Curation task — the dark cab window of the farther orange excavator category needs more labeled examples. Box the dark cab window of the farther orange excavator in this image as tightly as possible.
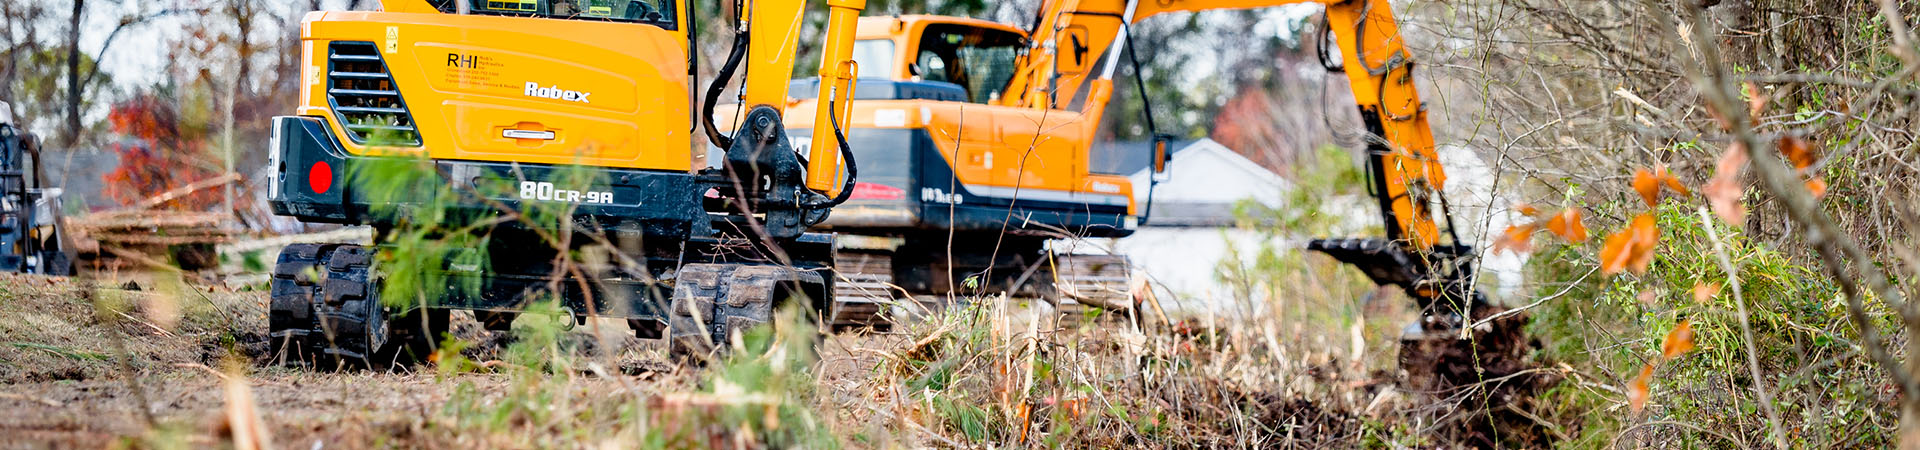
[910,25,1025,104]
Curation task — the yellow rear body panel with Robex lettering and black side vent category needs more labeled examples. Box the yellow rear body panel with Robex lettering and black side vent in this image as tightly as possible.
[298,0,693,171]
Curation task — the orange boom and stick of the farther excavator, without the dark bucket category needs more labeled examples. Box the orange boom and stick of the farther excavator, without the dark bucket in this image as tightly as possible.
[1002,0,1446,252]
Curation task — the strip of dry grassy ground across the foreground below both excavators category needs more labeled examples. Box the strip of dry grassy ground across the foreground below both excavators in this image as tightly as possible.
[0,255,1559,448]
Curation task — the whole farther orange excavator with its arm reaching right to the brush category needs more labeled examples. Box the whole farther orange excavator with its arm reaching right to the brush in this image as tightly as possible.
[787,0,1484,327]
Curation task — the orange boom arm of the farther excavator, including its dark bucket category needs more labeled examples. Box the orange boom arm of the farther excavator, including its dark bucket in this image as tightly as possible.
[1000,0,1480,315]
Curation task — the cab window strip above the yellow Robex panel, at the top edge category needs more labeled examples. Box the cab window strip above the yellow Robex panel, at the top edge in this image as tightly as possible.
[430,0,680,29]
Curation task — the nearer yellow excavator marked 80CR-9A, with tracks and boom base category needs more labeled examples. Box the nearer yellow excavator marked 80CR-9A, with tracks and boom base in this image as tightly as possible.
[267,0,866,362]
